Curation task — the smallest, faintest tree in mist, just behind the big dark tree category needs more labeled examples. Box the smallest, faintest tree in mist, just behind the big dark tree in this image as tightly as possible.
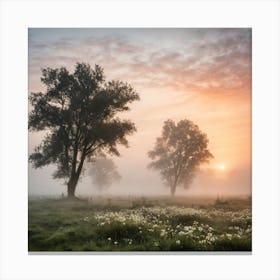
[88,157,121,191]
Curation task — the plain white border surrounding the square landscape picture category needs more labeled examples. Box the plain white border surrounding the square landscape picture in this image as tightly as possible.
[0,0,280,280]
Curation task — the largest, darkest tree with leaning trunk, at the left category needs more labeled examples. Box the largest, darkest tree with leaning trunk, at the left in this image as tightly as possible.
[29,63,139,198]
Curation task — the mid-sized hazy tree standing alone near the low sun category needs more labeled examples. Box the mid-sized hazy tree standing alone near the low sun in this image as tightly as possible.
[148,119,213,195]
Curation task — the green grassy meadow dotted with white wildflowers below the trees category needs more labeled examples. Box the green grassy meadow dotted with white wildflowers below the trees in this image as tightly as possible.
[28,197,252,251]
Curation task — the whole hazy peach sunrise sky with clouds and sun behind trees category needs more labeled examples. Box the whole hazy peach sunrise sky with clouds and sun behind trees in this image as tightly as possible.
[28,28,252,195]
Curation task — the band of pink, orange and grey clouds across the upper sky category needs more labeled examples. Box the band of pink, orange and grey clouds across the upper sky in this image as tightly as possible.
[30,29,251,99]
